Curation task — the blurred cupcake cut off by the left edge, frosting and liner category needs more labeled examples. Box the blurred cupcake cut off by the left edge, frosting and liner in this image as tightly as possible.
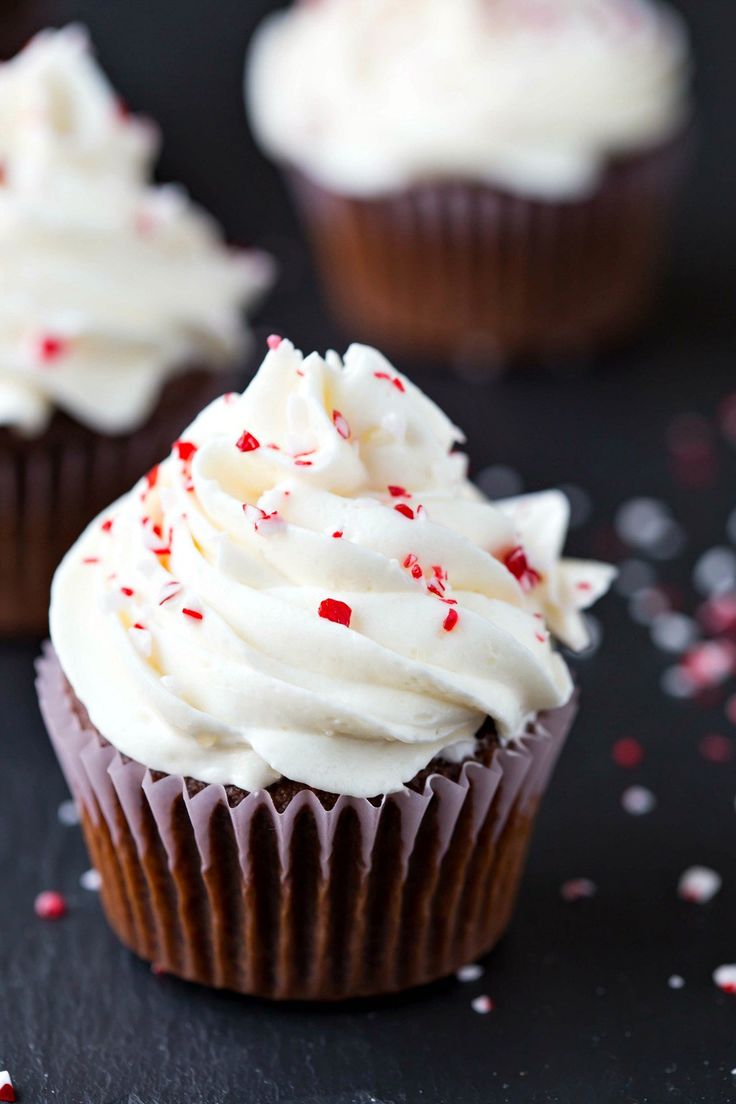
[0,28,269,635]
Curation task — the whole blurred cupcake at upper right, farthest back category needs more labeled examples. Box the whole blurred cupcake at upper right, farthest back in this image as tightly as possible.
[247,0,690,365]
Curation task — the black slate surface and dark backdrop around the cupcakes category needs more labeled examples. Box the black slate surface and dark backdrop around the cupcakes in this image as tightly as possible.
[0,0,736,1104]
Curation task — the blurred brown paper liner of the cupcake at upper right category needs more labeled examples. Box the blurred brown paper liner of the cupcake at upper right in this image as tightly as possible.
[292,138,689,362]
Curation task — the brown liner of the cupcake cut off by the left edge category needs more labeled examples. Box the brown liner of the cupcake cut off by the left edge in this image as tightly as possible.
[0,369,233,636]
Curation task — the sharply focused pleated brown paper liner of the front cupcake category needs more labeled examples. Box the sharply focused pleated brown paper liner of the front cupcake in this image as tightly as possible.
[38,646,576,1000]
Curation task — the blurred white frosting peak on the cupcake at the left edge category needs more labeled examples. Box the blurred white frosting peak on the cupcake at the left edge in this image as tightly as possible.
[0,28,269,434]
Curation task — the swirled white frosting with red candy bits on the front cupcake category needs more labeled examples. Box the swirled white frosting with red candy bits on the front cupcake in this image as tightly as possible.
[51,341,612,797]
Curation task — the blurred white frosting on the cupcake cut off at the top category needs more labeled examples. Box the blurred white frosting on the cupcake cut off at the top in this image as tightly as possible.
[247,0,690,200]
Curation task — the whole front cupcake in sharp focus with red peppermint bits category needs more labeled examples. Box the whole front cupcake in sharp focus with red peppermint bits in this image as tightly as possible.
[39,339,611,999]
